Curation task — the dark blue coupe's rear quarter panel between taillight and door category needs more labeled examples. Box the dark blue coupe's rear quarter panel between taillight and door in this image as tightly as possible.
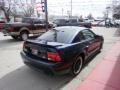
[58,43,85,64]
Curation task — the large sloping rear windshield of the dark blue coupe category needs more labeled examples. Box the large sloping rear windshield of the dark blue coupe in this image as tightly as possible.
[38,30,74,43]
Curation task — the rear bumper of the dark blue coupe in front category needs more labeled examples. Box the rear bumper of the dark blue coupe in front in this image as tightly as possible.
[20,51,70,74]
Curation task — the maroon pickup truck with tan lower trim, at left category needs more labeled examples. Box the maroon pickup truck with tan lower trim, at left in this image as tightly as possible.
[2,17,52,40]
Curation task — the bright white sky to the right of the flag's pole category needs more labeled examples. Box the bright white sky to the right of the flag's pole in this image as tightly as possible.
[47,0,112,17]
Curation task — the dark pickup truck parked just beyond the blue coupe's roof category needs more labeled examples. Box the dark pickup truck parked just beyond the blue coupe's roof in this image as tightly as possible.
[53,19,91,28]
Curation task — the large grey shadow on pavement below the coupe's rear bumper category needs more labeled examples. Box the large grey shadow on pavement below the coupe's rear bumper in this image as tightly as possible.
[0,66,73,90]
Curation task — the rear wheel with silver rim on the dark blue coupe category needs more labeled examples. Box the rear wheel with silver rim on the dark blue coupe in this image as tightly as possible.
[71,56,83,76]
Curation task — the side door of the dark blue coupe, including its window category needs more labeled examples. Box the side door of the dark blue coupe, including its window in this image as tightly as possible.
[81,29,97,55]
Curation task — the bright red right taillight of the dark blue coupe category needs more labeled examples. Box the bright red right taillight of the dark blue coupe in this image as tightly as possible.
[47,52,61,62]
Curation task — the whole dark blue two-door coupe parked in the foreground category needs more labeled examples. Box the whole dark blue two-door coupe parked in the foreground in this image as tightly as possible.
[21,26,104,75]
